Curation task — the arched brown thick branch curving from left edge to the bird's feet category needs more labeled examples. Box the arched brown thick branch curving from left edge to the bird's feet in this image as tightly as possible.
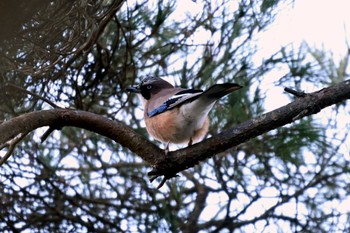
[0,109,163,164]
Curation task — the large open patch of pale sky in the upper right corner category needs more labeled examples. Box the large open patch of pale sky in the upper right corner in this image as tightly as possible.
[261,0,350,58]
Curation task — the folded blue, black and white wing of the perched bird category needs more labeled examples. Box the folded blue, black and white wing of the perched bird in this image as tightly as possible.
[148,89,203,117]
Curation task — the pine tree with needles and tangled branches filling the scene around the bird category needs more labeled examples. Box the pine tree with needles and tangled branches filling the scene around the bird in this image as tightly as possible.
[0,0,350,232]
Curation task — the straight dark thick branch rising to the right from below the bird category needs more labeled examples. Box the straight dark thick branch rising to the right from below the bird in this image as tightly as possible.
[149,80,350,177]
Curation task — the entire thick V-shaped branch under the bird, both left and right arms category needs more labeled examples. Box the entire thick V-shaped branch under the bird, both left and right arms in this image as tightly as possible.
[0,80,350,184]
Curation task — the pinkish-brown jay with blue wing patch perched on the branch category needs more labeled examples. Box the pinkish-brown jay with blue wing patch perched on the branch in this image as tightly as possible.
[127,76,242,153]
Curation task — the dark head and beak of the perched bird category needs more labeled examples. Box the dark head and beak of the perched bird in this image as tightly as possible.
[126,76,174,100]
